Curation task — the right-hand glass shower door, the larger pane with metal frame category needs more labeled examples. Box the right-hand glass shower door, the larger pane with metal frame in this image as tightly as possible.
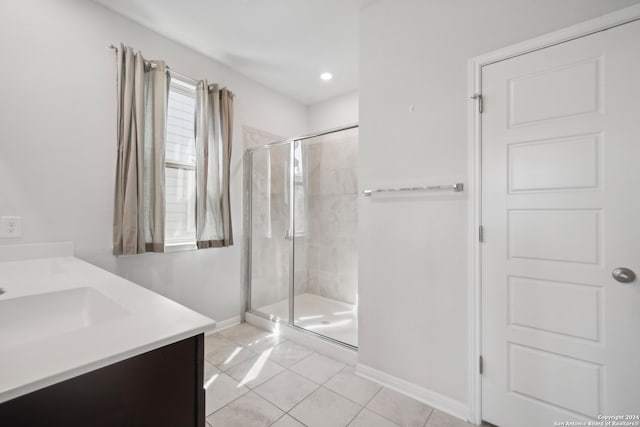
[290,129,358,347]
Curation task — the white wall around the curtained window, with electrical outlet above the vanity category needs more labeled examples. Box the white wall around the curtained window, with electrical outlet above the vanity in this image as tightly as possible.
[0,0,307,320]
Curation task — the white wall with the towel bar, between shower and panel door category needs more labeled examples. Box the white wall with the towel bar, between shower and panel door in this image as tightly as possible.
[358,0,637,414]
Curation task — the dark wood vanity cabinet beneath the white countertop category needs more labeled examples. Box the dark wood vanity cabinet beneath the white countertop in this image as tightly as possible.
[0,334,205,427]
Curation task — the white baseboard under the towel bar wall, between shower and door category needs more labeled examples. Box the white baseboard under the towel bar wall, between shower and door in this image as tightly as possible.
[356,363,469,421]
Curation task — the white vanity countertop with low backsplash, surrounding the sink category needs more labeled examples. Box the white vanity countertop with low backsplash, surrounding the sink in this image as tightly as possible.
[0,244,215,402]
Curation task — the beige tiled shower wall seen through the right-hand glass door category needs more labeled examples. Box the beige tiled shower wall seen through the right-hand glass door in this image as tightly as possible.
[299,130,358,304]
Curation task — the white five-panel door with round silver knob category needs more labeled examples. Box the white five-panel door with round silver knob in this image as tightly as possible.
[482,18,640,427]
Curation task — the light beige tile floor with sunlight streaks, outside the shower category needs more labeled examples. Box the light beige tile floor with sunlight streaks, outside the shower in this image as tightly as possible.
[204,323,478,427]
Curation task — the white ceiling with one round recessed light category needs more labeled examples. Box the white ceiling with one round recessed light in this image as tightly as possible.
[94,0,373,105]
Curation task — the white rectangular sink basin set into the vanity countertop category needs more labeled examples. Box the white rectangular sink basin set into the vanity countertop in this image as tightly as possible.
[0,287,129,348]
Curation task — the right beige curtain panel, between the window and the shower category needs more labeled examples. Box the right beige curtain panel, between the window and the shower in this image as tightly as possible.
[195,80,233,249]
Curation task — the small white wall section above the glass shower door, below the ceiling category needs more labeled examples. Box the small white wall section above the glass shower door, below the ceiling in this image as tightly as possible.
[307,92,359,133]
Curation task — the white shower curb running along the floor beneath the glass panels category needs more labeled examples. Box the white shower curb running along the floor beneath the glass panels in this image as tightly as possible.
[245,313,358,365]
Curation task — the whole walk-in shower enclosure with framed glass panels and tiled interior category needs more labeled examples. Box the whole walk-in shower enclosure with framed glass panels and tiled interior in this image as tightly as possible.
[244,125,358,347]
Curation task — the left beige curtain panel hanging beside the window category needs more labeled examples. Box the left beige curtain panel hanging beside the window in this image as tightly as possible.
[113,44,169,255]
